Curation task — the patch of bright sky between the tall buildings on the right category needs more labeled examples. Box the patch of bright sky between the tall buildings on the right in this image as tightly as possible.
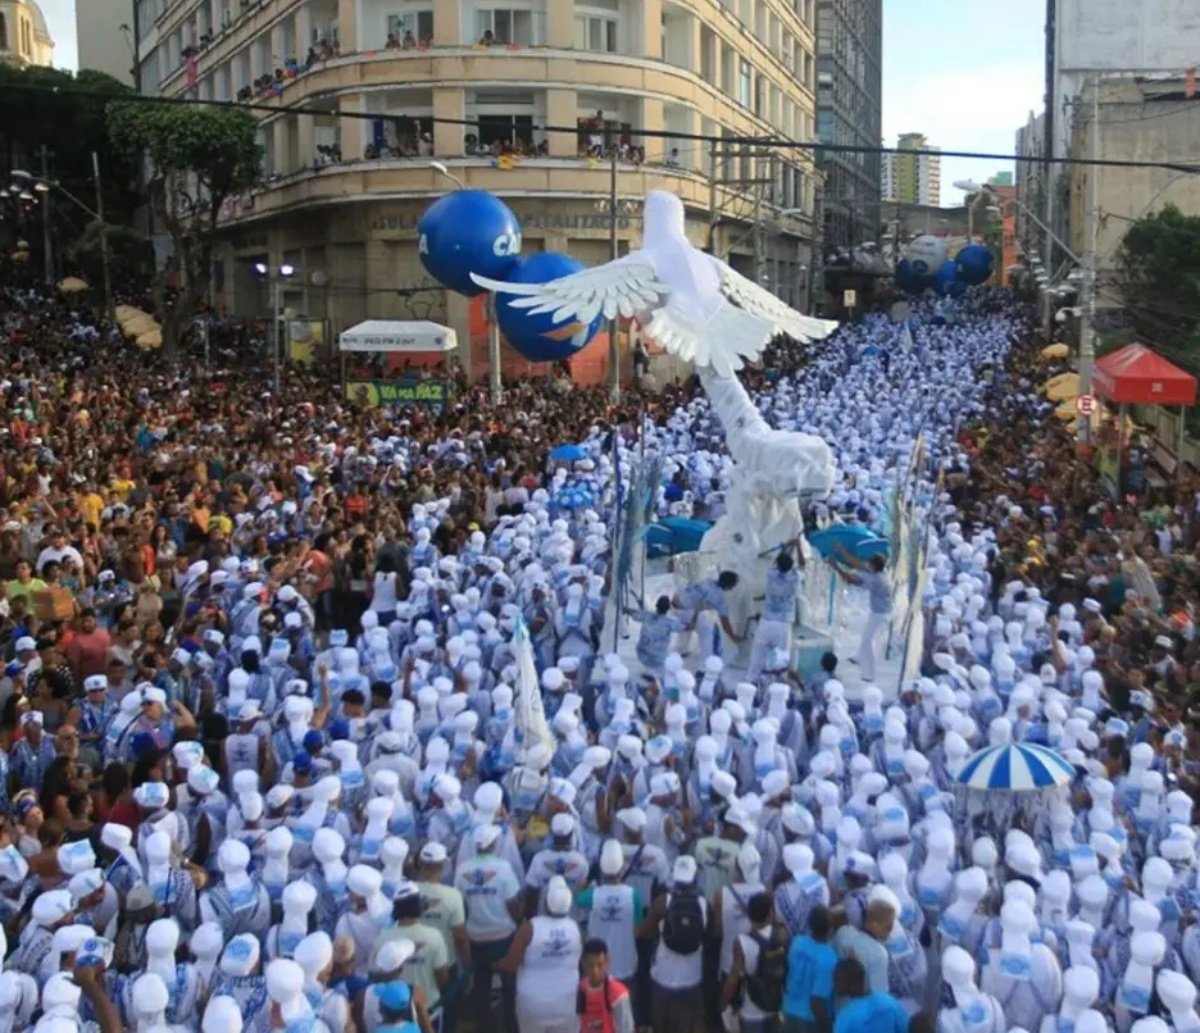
[883,0,1045,206]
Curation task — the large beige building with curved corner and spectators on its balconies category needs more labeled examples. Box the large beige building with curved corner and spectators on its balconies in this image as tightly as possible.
[137,0,817,369]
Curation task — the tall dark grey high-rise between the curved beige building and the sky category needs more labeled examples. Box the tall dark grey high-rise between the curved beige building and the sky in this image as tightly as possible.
[816,0,883,250]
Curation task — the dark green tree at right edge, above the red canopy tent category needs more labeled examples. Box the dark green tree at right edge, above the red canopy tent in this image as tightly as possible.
[1117,204,1200,348]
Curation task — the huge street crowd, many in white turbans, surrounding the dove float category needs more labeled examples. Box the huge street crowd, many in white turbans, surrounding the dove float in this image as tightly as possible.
[0,269,1200,1033]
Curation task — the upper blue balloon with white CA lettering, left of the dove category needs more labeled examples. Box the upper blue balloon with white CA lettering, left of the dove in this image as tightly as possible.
[416,190,521,298]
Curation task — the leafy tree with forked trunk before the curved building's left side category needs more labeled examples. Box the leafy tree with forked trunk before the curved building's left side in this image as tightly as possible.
[108,103,263,356]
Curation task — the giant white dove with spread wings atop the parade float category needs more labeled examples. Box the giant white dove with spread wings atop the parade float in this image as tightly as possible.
[470,191,838,377]
